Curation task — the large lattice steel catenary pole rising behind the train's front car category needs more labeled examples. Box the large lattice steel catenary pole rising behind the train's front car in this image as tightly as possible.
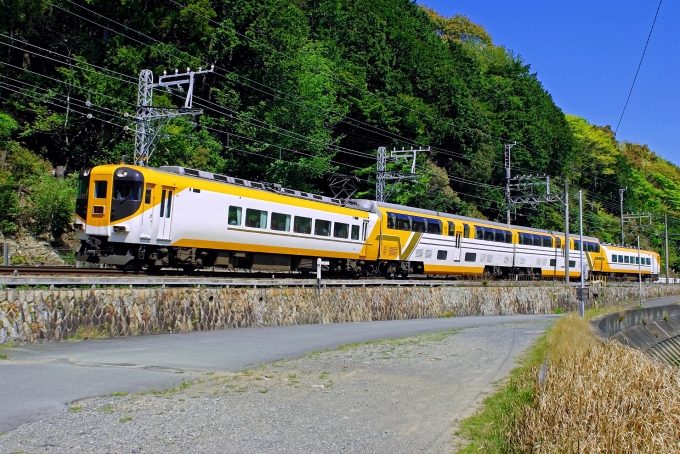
[134,67,213,166]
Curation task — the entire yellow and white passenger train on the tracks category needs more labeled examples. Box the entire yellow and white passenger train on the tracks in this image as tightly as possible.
[74,164,659,279]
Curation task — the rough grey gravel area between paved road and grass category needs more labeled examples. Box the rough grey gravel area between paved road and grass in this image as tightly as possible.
[0,322,548,453]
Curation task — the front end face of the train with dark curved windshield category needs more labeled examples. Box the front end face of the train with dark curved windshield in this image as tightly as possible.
[74,165,150,269]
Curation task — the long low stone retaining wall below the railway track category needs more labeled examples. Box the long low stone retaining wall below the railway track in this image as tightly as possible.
[0,285,680,344]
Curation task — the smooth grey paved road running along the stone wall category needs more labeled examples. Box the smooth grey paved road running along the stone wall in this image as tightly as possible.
[0,315,557,431]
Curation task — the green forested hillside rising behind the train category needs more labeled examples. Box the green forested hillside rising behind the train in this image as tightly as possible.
[0,0,680,267]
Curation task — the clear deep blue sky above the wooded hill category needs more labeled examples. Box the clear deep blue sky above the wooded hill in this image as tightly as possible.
[417,0,680,165]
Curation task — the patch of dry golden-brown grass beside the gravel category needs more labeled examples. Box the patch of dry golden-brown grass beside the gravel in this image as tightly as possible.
[508,317,680,453]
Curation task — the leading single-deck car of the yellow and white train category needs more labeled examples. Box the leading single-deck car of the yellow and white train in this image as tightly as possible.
[77,165,386,274]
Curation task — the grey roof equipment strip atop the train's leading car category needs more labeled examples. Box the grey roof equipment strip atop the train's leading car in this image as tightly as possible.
[155,166,369,211]
